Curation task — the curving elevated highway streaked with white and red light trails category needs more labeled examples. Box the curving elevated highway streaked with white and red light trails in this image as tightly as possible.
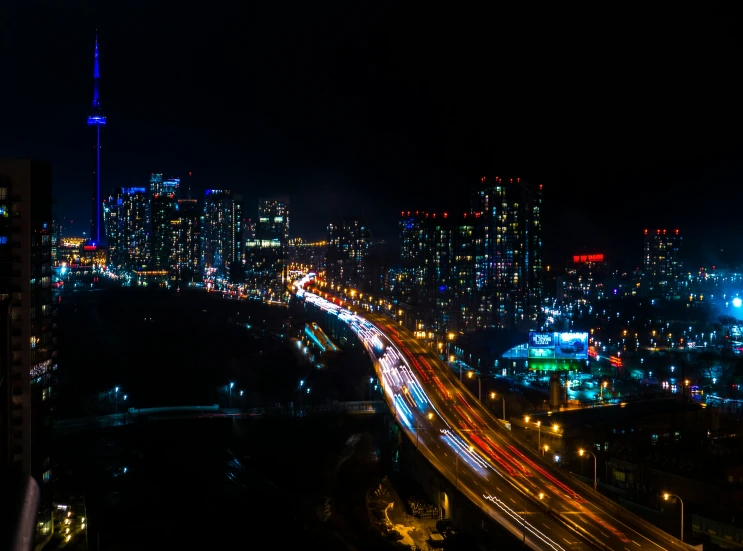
[295,278,692,551]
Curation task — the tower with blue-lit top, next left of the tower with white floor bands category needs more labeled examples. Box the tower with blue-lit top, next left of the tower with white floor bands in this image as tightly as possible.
[201,189,242,280]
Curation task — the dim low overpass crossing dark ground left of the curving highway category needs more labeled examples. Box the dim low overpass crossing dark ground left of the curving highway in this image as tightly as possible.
[53,401,389,437]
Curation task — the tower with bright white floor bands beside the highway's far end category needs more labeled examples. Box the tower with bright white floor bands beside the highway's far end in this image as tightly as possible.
[245,197,289,294]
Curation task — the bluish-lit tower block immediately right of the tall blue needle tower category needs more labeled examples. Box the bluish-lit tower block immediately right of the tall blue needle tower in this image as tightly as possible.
[104,187,149,270]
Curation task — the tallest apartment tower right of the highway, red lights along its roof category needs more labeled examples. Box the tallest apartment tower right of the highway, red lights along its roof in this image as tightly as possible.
[471,176,542,329]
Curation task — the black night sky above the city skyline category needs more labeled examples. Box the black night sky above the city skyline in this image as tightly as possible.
[0,0,743,268]
